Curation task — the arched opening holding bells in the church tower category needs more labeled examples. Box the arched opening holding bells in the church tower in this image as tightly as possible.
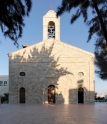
[48,21,55,39]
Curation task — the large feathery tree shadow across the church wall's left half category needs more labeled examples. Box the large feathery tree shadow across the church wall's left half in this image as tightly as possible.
[14,43,72,103]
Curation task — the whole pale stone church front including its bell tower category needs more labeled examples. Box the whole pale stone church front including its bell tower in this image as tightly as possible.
[8,10,94,104]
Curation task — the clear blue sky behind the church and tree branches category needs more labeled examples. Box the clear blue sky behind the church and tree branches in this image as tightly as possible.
[0,0,107,94]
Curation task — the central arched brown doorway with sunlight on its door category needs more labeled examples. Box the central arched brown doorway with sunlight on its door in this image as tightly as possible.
[48,85,55,104]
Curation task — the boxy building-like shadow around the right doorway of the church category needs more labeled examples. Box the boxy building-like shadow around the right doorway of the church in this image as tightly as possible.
[69,79,95,104]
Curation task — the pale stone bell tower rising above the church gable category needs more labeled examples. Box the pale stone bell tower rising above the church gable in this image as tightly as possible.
[43,10,60,40]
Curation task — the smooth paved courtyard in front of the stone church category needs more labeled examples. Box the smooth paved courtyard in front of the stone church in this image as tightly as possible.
[0,102,107,124]
